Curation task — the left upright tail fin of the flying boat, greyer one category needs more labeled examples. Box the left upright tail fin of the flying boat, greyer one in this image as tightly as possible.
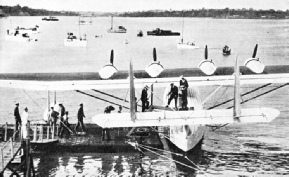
[129,61,136,121]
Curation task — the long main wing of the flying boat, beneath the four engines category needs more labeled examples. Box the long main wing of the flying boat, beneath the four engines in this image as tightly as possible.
[0,65,289,90]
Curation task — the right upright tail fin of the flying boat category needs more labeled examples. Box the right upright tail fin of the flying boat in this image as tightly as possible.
[234,55,241,118]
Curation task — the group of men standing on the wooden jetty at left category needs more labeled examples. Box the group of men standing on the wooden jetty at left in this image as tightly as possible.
[14,103,85,138]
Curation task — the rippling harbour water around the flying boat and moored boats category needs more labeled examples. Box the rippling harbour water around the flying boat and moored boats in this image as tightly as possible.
[0,17,289,176]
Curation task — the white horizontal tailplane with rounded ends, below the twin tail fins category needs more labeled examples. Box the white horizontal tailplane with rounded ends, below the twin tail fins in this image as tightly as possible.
[92,108,280,128]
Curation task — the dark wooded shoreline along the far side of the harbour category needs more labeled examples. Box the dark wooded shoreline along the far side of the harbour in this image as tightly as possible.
[0,5,289,19]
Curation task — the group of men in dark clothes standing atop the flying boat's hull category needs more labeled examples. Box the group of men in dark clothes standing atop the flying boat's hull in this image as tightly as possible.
[141,76,189,112]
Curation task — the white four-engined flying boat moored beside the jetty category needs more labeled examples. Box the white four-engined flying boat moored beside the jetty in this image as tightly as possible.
[0,46,289,152]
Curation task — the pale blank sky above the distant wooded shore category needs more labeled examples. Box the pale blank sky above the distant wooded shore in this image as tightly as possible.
[0,0,289,12]
